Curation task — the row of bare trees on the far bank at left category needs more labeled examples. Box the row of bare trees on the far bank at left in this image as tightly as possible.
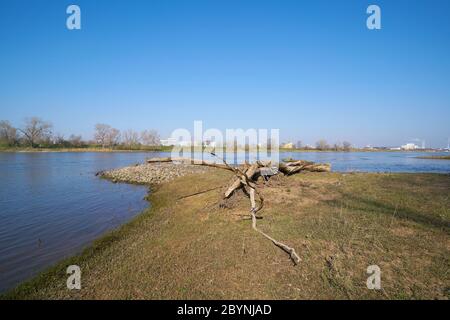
[0,117,160,150]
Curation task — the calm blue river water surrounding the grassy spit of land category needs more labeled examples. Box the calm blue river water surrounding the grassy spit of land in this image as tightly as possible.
[0,152,450,292]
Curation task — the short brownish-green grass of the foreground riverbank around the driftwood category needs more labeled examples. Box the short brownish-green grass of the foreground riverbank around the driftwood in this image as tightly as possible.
[3,170,450,299]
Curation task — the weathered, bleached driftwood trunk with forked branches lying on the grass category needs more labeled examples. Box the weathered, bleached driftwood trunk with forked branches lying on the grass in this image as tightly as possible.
[147,153,331,265]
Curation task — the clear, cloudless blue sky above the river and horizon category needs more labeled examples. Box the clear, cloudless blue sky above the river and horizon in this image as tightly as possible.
[0,0,450,147]
